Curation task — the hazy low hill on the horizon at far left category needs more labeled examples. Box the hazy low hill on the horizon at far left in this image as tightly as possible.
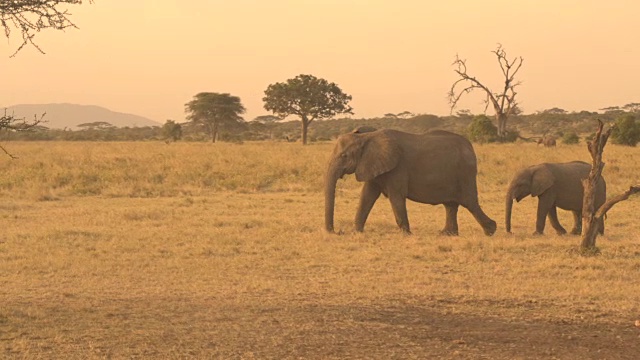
[7,104,162,130]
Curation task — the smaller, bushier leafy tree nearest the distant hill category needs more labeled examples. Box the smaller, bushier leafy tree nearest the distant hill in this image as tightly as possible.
[184,92,246,142]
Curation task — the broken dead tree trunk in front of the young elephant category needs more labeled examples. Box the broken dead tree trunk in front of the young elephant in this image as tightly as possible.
[580,120,640,253]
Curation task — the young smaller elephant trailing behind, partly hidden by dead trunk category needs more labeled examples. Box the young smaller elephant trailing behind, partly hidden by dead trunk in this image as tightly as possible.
[505,161,607,235]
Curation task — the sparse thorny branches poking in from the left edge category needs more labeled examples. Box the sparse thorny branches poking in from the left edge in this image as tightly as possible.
[0,0,93,158]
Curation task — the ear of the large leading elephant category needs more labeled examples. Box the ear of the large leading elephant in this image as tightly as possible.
[356,132,401,181]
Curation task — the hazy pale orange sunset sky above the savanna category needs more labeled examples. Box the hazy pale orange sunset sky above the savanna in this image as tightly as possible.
[0,0,640,123]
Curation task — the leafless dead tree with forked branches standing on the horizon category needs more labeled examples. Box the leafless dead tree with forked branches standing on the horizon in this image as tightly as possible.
[448,44,524,139]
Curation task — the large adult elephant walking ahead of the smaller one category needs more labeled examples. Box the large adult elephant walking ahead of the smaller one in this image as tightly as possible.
[325,129,496,235]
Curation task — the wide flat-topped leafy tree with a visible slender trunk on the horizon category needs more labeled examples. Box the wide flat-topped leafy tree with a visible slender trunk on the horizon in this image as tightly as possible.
[262,75,353,145]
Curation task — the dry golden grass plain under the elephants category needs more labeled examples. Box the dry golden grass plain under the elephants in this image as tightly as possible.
[0,142,640,359]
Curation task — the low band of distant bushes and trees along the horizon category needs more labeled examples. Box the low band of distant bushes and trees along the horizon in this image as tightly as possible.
[0,108,640,146]
